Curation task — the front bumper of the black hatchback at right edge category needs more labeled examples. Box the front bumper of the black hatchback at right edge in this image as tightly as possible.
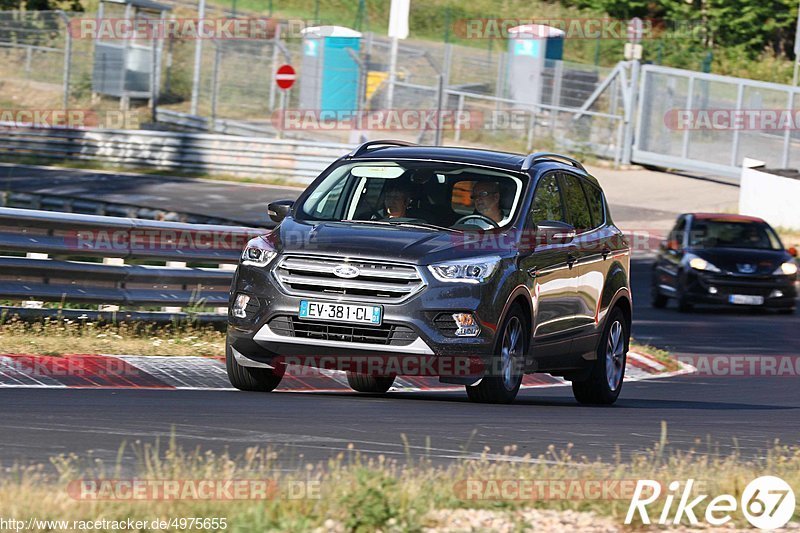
[684,270,798,309]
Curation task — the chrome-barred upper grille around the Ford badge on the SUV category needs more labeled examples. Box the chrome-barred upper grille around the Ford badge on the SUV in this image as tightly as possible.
[274,255,425,302]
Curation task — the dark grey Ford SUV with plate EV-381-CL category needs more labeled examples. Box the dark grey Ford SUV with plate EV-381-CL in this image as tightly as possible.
[226,141,631,404]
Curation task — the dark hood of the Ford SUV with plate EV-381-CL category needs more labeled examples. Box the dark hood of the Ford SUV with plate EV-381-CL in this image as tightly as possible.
[273,218,512,264]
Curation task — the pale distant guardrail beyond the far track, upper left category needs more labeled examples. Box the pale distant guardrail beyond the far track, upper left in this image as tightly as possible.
[0,123,352,183]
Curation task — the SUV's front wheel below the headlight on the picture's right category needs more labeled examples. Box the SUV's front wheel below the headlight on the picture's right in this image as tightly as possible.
[467,306,529,403]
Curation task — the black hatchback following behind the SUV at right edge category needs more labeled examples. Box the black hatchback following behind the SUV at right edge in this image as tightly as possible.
[651,213,797,313]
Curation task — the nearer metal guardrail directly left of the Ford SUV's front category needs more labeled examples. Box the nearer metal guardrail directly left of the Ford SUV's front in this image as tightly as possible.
[0,208,265,322]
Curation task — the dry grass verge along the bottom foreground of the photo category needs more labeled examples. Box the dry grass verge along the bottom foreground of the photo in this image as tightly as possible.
[0,425,800,531]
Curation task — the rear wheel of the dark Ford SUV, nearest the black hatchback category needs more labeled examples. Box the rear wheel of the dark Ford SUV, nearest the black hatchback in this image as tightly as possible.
[572,307,630,405]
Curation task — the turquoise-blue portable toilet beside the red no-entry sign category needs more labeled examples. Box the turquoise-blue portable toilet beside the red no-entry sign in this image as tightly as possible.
[299,26,361,117]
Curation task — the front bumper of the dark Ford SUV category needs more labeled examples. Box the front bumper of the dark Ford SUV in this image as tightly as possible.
[228,258,505,374]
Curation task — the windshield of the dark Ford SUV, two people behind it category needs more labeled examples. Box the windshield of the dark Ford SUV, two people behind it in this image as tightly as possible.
[296,161,526,230]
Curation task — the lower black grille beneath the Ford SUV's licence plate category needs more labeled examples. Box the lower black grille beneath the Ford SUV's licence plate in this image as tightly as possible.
[269,316,417,346]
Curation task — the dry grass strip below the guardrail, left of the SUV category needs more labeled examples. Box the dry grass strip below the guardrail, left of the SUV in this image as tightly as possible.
[0,318,225,356]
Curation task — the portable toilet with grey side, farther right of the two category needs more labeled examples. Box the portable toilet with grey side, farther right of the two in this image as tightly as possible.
[507,24,565,109]
